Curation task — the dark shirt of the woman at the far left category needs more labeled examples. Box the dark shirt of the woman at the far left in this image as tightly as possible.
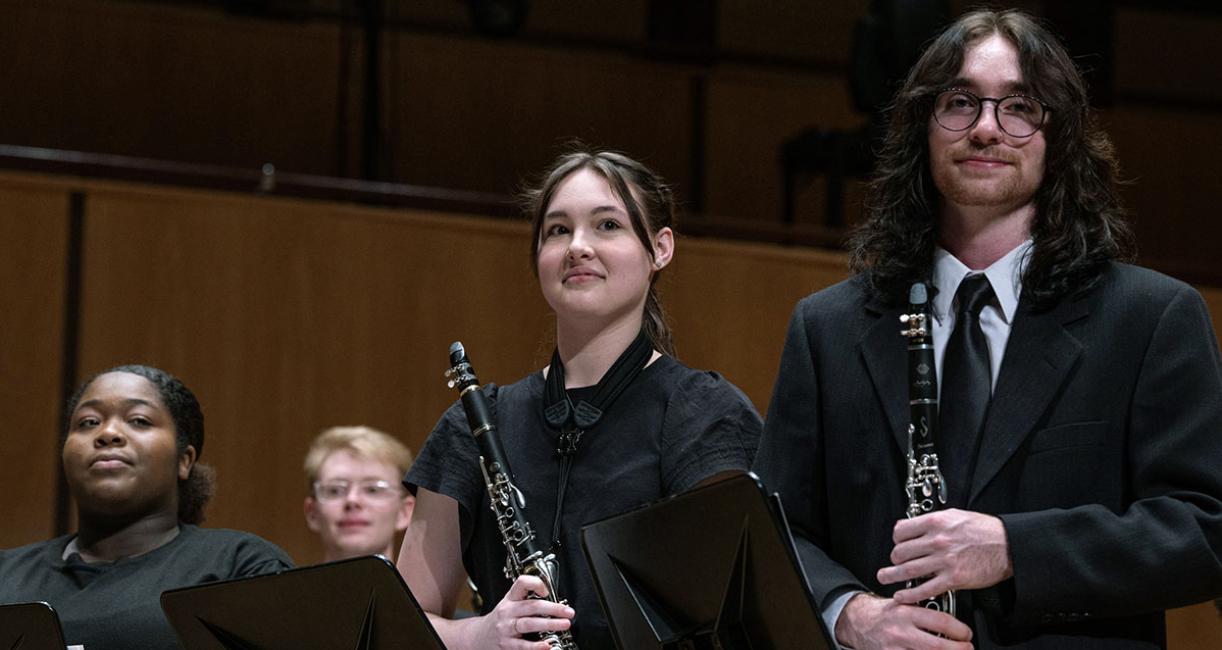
[0,524,292,650]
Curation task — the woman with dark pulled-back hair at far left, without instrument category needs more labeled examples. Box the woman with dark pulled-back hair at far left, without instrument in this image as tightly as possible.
[0,365,292,650]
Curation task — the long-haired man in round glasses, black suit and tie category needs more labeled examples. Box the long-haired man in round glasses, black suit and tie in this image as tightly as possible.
[755,10,1222,650]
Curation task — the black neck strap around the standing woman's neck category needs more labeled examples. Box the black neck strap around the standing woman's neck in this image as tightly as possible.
[543,329,654,444]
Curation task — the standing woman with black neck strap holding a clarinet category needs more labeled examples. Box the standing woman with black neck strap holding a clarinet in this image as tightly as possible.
[400,152,761,650]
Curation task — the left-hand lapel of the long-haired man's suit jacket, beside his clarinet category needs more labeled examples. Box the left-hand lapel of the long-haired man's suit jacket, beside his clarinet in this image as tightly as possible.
[858,301,910,453]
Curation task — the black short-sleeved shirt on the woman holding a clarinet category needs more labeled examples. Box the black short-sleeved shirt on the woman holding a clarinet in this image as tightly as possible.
[403,356,763,650]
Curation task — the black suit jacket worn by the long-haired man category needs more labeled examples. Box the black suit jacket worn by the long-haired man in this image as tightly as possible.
[755,264,1222,649]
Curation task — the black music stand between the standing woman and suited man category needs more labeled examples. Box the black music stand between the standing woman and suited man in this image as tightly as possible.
[582,473,836,650]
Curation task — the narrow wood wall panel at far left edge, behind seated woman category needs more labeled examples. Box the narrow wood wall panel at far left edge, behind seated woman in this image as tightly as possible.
[0,176,68,549]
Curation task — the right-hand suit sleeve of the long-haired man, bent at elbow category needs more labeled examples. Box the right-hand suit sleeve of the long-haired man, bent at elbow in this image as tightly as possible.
[1002,285,1222,624]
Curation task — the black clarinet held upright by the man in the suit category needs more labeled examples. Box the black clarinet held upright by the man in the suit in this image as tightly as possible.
[899,282,954,616]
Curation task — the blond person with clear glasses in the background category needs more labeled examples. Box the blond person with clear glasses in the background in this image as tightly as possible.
[306,426,415,562]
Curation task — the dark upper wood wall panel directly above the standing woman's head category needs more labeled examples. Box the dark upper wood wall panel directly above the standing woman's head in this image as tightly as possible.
[387,34,692,195]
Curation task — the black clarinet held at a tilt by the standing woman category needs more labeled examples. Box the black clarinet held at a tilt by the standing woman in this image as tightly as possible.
[446,341,578,650]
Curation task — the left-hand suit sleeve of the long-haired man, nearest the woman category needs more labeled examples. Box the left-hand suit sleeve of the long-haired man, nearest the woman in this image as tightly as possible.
[754,298,868,608]
